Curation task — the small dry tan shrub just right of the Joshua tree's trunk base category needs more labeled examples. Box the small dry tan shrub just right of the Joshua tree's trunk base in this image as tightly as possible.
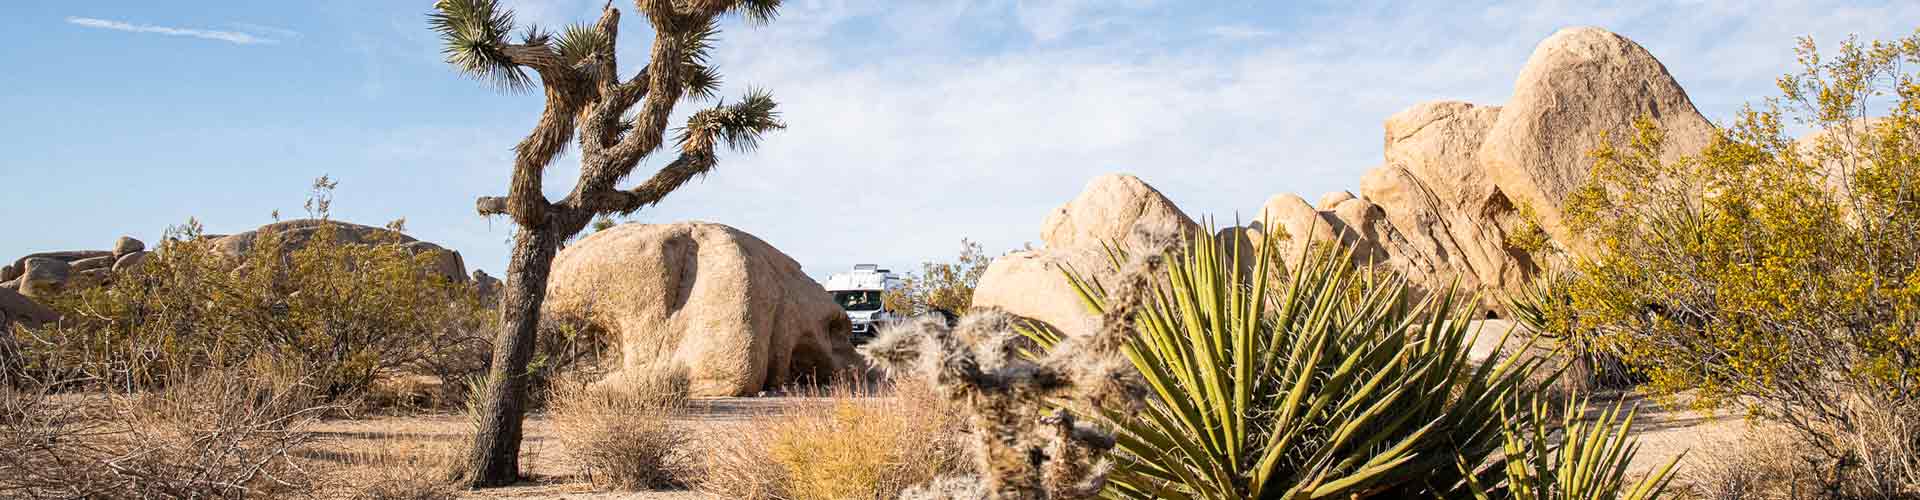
[547,369,697,490]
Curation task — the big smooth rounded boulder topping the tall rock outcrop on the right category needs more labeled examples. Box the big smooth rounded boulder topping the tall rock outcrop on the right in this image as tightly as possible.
[1478,27,1715,252]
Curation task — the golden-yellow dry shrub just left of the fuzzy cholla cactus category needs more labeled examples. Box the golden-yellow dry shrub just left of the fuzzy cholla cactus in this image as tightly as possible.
[699,381,966,500]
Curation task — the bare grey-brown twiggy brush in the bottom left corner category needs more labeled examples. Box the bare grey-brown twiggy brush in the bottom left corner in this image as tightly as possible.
[0,369,330,498]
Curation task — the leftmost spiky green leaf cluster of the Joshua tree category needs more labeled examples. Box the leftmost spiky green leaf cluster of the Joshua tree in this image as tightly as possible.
[426,0,534,90]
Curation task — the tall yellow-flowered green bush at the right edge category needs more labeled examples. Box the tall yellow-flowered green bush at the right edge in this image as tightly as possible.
[1569,35,1920,496]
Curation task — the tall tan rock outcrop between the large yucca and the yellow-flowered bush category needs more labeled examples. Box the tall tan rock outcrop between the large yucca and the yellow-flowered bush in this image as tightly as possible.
[1267,27,1715,310]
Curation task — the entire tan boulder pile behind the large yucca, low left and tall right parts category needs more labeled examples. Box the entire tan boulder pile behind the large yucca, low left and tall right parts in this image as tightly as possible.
[973,27,1716,329]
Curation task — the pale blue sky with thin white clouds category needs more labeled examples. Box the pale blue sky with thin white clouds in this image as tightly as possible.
[0,0,1920,277]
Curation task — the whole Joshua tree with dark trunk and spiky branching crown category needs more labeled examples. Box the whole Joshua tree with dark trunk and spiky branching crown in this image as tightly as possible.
[428,0,783,487]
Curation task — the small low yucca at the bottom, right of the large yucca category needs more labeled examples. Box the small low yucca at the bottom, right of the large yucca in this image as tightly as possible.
[1459,396,1686,500]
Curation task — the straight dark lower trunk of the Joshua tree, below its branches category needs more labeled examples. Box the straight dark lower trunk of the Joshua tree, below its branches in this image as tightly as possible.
[467,229,561,487]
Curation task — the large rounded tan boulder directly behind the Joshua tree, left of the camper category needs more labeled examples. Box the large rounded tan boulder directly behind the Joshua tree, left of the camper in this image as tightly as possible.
[545,223,858,396]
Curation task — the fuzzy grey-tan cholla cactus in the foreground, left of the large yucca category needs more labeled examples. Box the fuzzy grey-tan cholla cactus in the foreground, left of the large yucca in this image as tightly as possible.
[862,252,1160,498]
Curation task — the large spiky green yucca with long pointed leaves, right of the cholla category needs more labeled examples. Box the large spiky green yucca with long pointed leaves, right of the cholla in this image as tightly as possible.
[1029,228,1540,498]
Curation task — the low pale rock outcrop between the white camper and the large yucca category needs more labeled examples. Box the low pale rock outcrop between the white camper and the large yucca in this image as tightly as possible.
[973,175,1200,333]
